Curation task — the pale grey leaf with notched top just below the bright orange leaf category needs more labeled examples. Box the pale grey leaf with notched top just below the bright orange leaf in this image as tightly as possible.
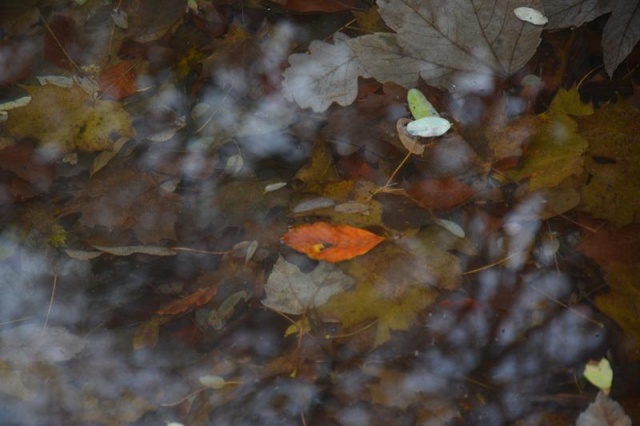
[262,257,355,315]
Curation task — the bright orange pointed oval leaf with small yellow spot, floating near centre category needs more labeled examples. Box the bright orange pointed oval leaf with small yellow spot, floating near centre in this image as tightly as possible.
[282,222,384,263]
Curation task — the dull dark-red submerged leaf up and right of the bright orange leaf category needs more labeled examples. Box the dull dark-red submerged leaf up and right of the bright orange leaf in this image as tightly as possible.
[407,179,473,210]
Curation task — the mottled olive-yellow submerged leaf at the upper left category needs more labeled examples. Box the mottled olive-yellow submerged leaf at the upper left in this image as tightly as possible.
[6,85,133,153]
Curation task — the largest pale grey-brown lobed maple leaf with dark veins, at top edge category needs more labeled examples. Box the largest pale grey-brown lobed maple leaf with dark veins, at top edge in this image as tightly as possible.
[283,0,542,111]
